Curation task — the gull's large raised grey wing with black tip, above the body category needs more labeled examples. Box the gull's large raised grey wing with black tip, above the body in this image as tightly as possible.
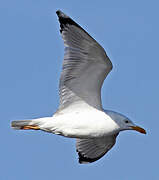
[56,11,112,109]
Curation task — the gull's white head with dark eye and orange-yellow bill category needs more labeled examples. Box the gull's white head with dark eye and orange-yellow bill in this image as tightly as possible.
[104,110,146,134]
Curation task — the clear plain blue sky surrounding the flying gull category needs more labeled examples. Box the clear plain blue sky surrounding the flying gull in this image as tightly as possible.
[0,0,159,180]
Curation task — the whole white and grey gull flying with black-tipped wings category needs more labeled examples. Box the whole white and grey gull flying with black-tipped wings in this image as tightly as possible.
[11,10,146,164]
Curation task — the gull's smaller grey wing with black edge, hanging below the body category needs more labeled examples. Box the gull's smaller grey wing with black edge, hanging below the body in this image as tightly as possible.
[76,134,118,164]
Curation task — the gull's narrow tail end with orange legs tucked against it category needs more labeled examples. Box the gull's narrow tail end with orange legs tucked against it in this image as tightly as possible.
[11,120,40,130]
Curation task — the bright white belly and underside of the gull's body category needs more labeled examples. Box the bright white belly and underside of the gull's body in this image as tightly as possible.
[40,108,118,138]
